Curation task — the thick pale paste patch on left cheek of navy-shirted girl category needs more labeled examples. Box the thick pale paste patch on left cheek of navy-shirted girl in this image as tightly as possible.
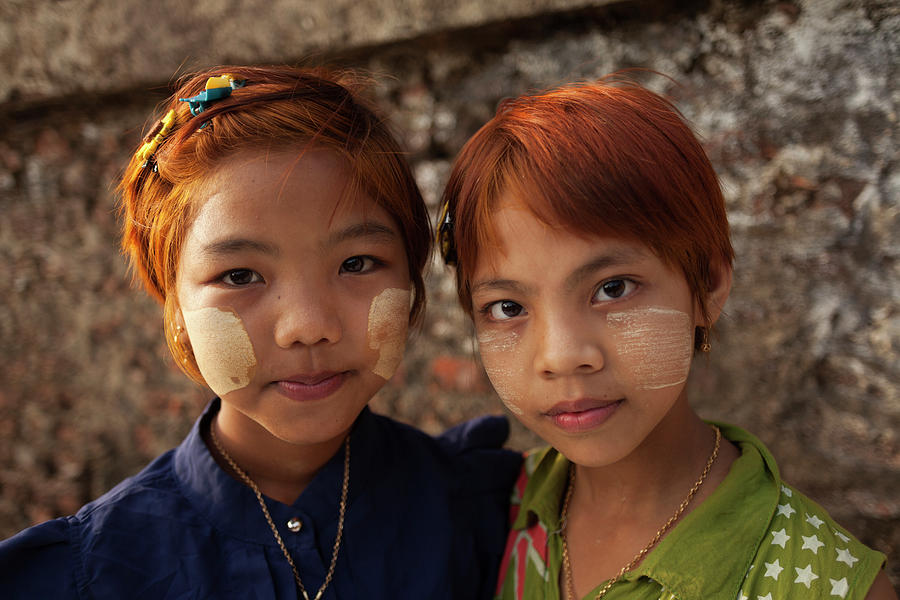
[182,307,256,396]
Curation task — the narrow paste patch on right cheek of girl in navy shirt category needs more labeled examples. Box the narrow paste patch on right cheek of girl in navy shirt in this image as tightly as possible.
[366,288,412,380]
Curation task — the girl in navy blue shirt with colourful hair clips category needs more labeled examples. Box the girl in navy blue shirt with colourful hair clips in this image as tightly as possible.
[0,67,520,600]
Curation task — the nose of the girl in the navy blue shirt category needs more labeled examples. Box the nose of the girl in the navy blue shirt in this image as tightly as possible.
[275,284,343,348]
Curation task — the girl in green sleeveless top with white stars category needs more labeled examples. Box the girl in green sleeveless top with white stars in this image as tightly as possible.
[439,78,896,600]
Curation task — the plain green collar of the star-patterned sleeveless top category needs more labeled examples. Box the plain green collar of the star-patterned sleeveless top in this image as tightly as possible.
[513,423,782,600]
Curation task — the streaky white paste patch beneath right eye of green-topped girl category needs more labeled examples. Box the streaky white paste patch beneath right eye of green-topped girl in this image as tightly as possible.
[606,307,694,390]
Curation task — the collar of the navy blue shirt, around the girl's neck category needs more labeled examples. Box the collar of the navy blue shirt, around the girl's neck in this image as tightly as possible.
[175,398,380,544]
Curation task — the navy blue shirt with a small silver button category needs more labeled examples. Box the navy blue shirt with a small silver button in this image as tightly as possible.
[0,400,521,600]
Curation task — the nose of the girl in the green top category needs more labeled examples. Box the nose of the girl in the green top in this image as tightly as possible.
[534,315,605,378]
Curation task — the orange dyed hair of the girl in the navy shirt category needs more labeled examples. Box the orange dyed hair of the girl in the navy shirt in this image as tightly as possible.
[119,66,432,382]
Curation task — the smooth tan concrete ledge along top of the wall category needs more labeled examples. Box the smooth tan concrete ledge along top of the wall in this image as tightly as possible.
[0,0,613,103]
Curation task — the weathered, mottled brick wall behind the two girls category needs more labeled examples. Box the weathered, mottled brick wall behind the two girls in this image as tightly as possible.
[0,0,900,585]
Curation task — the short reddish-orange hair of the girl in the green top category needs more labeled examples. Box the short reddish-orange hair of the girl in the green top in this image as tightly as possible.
[443,77,734,328]
